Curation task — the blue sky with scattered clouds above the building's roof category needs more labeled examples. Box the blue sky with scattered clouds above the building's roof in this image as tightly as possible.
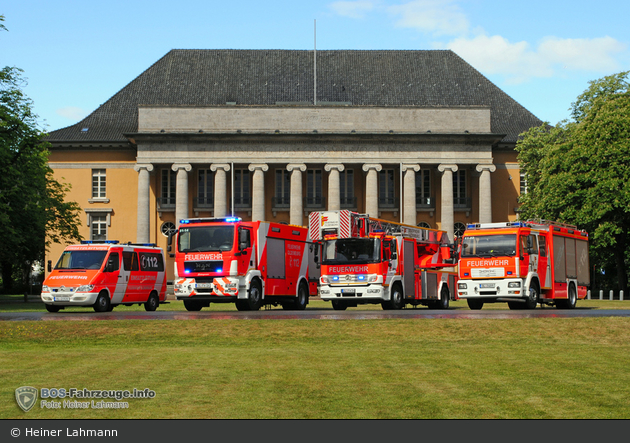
[0,0,630,131]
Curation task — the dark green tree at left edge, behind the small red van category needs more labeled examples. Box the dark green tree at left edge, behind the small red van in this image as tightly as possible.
[0,16,81,292]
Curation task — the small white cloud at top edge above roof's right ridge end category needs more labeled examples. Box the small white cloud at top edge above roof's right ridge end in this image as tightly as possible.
[387,0,470,35]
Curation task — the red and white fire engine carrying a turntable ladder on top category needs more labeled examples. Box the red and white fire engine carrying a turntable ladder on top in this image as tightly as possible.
[309,210,457,310]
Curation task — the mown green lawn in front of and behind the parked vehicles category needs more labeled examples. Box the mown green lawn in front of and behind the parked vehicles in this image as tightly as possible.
[0,300,630,419]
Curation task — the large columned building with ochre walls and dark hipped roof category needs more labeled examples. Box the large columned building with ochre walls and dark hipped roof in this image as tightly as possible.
[48,50,542,278]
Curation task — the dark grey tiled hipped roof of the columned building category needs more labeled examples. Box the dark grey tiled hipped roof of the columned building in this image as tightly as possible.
[48,50,542,143]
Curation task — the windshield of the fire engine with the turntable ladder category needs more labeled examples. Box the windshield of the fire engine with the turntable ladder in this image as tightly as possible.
[322,238,381,264]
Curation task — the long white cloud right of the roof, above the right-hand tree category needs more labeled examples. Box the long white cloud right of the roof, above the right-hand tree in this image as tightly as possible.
[446,35,625,83]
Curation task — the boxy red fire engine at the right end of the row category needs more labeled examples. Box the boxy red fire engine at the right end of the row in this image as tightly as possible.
[457,221,590,309]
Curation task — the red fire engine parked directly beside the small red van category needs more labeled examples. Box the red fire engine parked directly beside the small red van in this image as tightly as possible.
[168,217,317,311]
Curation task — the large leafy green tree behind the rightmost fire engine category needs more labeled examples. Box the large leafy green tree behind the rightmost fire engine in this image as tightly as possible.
[516,71,630,294]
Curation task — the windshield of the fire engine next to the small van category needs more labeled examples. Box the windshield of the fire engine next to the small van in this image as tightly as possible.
[177,225,234,252]
